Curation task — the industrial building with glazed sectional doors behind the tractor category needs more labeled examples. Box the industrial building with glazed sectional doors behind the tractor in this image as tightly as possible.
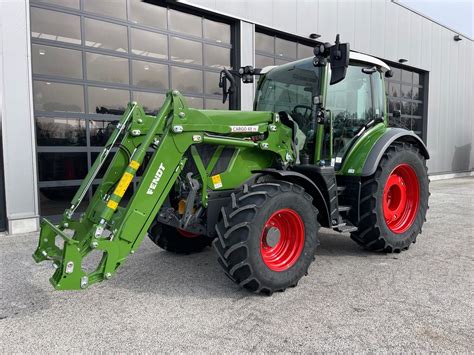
[0,0,474,234]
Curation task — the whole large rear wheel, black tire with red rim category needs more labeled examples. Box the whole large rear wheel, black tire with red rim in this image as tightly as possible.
[351,143,429,252]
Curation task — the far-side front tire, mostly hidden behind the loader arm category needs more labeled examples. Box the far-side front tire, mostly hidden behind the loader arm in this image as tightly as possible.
[148,221,211,254]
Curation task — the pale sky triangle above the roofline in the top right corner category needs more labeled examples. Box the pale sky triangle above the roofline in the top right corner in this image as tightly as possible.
[398,0,474,38]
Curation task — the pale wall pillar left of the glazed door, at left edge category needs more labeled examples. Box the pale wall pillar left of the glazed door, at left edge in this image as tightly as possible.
[0,0,38,234]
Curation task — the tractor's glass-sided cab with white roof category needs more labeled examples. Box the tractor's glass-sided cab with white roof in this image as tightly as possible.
[254,52,390,170]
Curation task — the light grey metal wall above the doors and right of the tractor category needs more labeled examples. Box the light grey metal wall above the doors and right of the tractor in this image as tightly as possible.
[180,0,474,174]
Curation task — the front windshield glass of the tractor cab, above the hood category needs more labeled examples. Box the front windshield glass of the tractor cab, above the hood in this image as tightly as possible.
[255,58,321,119]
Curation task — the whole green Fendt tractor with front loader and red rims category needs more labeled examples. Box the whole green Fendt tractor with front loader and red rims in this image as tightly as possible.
[33,37,429,294]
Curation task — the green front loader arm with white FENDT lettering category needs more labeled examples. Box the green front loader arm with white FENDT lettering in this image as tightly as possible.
[33,91,296,290]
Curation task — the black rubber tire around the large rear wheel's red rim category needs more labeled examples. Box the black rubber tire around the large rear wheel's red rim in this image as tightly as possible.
[351,143,430,253]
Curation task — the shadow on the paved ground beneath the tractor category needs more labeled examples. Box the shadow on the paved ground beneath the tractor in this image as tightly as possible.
[108,229,373,298]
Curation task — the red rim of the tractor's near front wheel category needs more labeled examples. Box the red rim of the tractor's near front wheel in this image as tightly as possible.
[260,208,304,271]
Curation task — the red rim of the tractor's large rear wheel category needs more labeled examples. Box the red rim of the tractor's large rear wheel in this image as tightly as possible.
[383,164,420,234]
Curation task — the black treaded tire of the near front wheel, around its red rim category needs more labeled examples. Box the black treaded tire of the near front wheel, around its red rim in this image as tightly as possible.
[213,181,319,295]
